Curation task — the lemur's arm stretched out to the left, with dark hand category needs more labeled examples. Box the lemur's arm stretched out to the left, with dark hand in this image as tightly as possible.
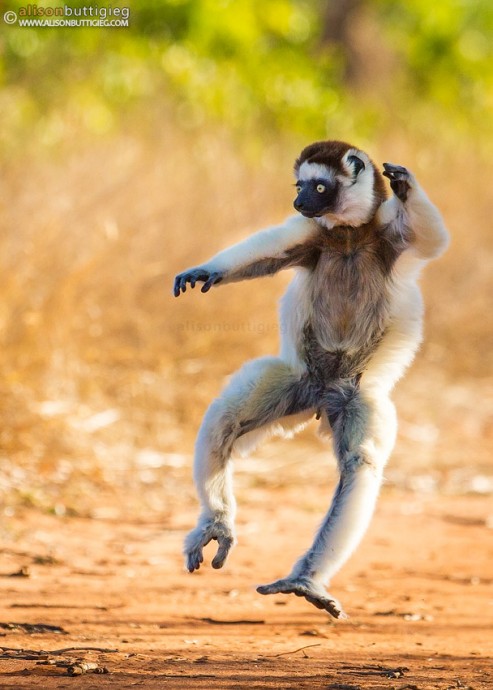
[174,216,317,297]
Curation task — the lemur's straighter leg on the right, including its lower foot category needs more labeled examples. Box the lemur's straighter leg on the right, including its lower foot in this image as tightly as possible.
[257,385,397,618]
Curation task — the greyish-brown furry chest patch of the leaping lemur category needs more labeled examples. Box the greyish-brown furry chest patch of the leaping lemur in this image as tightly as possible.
[308,245,387,350]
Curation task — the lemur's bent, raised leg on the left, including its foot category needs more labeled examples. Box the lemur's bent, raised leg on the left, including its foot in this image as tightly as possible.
[184,357,310,572]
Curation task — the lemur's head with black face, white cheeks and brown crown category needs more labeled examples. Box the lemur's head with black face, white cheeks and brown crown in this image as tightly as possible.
[294,141,386,227]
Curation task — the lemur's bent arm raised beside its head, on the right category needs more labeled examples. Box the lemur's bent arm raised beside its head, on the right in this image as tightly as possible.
[377,163,449,261]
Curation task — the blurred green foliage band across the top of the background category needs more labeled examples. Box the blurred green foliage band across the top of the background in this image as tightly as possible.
[0,0,493,151]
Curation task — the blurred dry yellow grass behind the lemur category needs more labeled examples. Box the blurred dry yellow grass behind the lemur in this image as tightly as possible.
[0,124,493,511]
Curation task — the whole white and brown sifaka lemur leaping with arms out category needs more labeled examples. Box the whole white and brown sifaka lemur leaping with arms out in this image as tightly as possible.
[174,141,448,618]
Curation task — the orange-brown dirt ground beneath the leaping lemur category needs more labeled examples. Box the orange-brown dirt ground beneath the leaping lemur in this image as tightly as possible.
[0,488,493,690]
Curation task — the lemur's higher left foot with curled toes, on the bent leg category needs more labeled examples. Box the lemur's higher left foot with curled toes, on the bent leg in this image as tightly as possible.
[183,516,235,573]
